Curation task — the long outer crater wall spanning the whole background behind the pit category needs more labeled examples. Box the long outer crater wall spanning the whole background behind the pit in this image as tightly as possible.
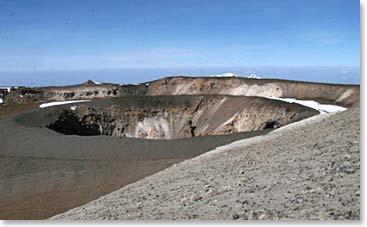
[4,77,360,107]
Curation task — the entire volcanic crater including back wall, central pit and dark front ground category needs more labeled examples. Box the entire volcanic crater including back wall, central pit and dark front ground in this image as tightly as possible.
[0,77,360,219]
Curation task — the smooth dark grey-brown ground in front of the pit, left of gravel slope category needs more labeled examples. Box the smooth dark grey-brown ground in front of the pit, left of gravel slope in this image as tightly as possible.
[0,100,267,219]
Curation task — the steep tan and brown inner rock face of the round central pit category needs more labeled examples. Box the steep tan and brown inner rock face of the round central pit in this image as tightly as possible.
[47,95,318,139]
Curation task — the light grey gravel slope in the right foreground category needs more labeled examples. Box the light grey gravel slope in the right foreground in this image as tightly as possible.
[51,107,360,220]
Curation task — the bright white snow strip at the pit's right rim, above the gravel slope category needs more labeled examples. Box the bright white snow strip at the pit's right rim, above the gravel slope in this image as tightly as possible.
[266,96,347,114]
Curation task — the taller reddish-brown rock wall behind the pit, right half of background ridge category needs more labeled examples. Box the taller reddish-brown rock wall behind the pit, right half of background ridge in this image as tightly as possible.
[147,77,360,107]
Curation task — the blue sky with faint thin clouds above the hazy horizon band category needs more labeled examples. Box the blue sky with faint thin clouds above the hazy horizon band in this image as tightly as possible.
[0,0,360,71]
